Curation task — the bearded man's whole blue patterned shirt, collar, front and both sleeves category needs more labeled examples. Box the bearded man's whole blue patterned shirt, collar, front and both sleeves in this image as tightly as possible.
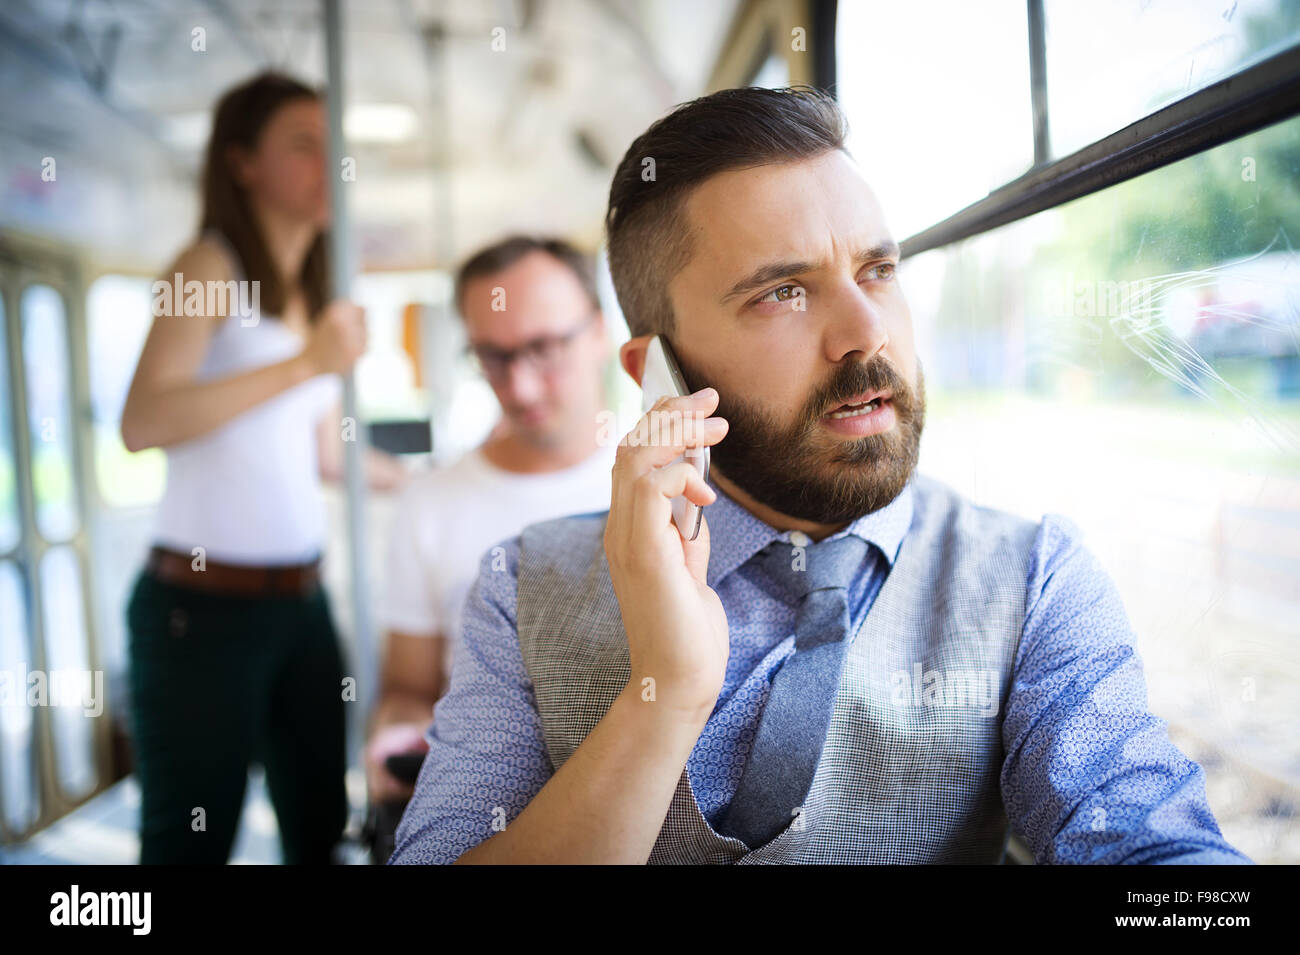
[390,470,1251,864]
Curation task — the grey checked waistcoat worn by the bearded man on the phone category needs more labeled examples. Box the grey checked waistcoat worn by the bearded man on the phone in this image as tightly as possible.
[516,473,1037,863]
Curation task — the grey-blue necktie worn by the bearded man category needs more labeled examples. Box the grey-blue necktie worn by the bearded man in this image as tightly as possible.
[718,534,867,848]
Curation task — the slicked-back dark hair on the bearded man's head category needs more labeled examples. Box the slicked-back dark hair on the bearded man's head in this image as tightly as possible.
[605,87,849,335]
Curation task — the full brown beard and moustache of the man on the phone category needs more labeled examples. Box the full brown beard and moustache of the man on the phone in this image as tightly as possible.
[677,355,926,524]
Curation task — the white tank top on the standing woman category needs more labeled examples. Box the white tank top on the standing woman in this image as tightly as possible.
[153,234,342,565]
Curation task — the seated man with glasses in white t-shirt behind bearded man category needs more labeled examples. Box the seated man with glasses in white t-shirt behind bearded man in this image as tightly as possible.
[367,236,615,804]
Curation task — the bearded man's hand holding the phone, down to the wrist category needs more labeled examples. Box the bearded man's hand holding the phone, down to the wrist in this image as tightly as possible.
[605,388,729,719]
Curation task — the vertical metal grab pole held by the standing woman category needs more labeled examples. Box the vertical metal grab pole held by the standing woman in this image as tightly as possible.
[322,0,374,741]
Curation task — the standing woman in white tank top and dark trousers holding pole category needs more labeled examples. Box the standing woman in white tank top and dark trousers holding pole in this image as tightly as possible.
[122,74,398,863]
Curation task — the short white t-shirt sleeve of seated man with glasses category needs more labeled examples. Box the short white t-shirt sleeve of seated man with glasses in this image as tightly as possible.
[381,479,441,637]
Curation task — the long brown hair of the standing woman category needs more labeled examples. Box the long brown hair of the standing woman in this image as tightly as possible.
[199,73,329,322]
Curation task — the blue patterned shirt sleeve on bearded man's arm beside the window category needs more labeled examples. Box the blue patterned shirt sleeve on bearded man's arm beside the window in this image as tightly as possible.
[1001,515,1251,864]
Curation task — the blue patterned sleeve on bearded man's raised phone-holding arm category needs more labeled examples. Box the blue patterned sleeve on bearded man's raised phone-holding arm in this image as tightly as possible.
[389,537,553,865]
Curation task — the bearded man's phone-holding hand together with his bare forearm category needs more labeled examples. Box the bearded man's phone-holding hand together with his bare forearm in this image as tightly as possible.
[458,388,729,865]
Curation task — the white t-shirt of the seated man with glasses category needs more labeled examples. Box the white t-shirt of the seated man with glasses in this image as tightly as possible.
[380,444,618,677]
